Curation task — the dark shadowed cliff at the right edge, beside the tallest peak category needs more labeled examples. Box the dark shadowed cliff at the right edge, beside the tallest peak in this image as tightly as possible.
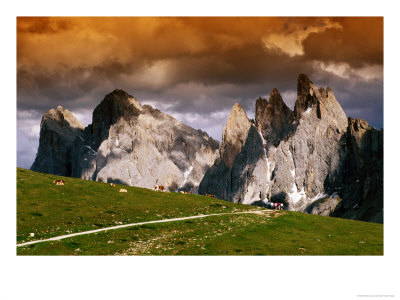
[332,118,383,223]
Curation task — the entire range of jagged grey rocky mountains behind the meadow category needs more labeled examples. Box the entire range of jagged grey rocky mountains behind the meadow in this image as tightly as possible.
[31,74,383,223]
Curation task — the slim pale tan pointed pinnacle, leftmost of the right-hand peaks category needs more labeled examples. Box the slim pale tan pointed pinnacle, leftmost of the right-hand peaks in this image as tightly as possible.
[221,103,251,168]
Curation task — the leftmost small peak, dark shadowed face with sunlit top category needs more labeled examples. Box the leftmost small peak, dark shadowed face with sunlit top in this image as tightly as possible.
[31,106,84,176]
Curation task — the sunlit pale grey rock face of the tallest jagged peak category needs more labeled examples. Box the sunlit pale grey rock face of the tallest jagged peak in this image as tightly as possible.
[270,75,347,210]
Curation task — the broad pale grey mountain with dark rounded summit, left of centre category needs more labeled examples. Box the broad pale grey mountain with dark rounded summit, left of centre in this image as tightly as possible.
[32,90,219,192]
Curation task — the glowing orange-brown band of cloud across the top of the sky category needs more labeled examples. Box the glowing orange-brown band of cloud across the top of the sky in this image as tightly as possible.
[17,17,383,96]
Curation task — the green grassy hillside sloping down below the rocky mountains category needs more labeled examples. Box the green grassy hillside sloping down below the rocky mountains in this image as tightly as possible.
[17,168,383,255]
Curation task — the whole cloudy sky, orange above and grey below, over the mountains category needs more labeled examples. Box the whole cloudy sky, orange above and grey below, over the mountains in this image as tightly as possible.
[17,17,383,168]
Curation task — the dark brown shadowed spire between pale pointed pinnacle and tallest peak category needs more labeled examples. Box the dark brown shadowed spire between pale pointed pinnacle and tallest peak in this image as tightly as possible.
[255,88,294,147]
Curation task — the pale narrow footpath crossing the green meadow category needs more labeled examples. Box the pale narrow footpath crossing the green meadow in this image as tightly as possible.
[17,210,265,247]
